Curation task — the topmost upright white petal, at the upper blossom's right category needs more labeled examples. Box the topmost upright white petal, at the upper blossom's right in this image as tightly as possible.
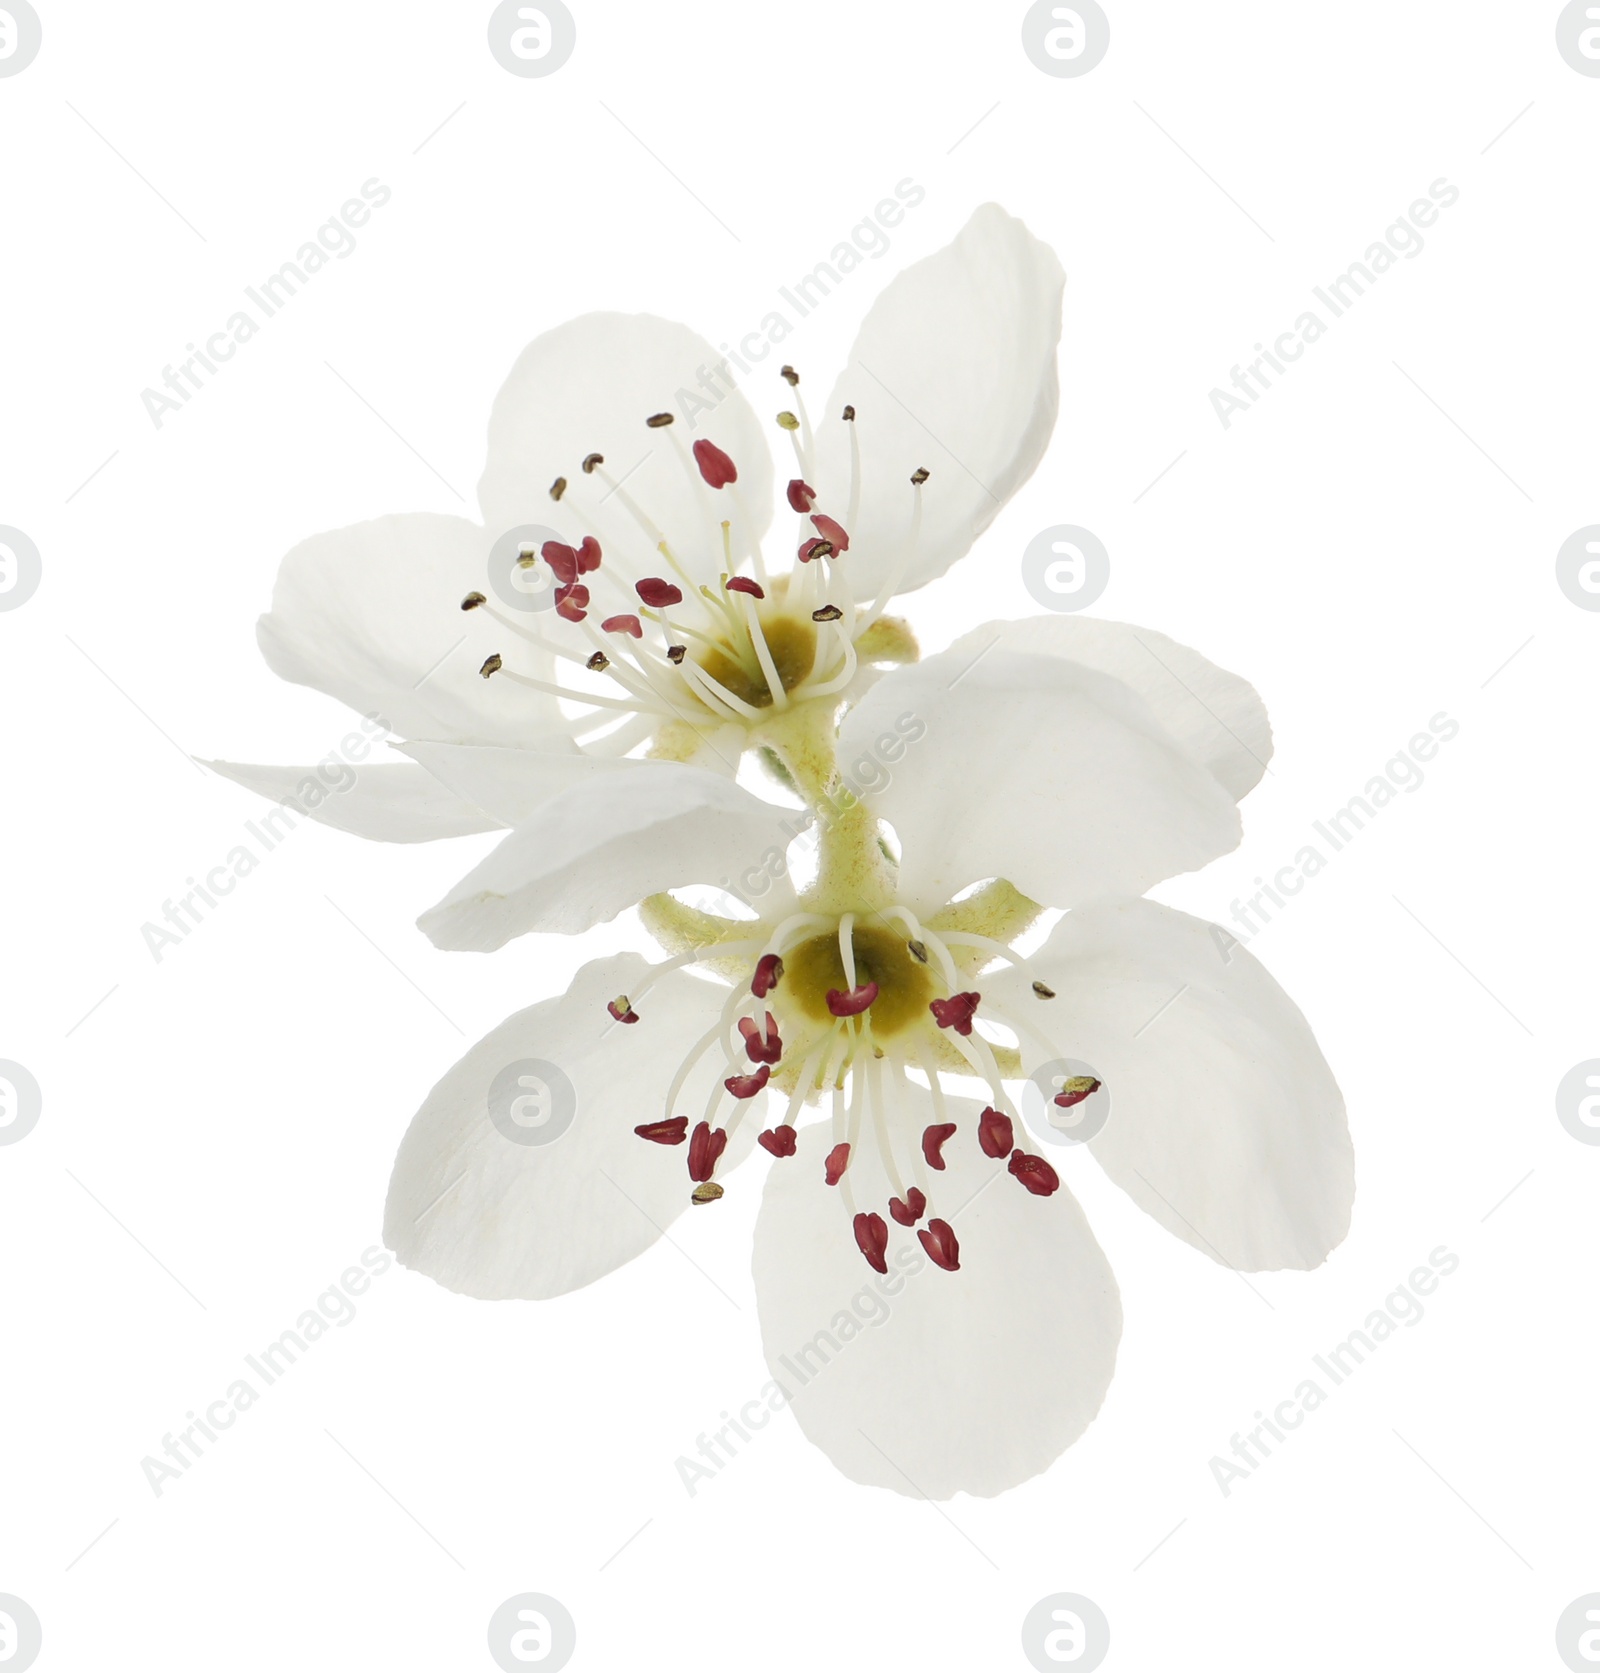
[813,204,1066,599]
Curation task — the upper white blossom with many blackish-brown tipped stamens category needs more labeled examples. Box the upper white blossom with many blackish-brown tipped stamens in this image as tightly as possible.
[211,204,1064,945]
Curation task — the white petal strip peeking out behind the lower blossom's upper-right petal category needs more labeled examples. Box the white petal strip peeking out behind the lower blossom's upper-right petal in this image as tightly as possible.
[951,616,1272,801]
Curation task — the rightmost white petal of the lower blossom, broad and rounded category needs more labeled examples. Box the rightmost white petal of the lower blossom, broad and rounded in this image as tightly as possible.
[982,900,1356,1271]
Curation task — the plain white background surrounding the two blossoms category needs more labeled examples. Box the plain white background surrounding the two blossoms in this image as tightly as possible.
[0,0,1600,1670]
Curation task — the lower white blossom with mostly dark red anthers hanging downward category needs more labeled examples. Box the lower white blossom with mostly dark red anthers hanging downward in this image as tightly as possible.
[385,617,1354,1497]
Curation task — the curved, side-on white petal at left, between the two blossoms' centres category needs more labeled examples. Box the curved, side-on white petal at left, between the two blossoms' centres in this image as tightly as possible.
[417,761,797,952]
